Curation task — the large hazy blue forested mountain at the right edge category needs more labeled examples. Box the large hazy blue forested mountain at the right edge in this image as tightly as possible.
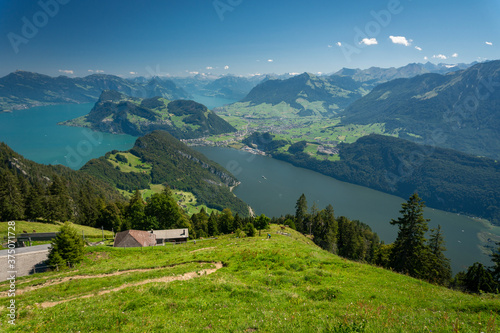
[342,61,500,159]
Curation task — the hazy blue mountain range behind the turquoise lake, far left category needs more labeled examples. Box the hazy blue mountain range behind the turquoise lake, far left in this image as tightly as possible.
[0,71,190,112]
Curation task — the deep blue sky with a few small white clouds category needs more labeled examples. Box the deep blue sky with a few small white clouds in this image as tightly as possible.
[0,0,500,77]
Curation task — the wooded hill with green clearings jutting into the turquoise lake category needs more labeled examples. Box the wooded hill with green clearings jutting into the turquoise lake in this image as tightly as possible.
[61,91,235,139]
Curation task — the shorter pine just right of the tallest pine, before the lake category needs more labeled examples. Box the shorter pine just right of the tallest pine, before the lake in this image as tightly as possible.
[426,225,451,285]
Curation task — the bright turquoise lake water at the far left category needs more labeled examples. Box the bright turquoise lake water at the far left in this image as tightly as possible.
[0,103,136,170]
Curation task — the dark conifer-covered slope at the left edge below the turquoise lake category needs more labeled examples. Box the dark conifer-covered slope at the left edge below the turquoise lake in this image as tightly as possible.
[0,142,124,224]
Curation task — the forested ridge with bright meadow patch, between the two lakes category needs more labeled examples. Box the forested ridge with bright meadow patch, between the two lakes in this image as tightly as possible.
[81,131,249,216]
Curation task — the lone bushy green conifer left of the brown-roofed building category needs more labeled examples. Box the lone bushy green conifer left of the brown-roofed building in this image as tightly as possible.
[48,222,84,268]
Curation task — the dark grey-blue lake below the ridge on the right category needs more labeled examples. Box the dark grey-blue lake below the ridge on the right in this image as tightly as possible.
[196,147,500,273]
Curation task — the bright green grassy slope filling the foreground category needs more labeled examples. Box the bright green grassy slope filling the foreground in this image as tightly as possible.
[0,226,500,332]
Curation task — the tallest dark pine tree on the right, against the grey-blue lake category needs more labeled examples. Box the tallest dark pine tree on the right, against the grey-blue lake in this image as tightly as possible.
[390,193,429,278]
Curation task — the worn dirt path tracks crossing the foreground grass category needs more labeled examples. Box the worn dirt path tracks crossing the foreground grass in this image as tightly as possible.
[0,262,222,300]
